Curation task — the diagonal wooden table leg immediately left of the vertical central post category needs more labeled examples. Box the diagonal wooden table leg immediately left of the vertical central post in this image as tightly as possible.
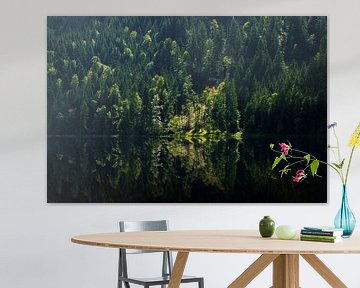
[228,254,279,288]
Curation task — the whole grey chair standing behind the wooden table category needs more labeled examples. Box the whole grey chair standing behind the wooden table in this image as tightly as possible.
[118,220,204,288]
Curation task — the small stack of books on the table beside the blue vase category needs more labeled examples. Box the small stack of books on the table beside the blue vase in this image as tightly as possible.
[300,226,344,243]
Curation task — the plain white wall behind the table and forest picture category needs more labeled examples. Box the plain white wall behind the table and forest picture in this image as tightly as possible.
[0,0,360,288]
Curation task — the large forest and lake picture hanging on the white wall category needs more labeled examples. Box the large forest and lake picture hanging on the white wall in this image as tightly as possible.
[47,16,327,203]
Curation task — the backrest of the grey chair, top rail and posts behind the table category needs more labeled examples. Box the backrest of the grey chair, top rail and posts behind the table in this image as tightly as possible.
[119,220,173,277]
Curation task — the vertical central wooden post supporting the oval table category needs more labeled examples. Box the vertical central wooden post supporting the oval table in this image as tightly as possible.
[272,254,299,288]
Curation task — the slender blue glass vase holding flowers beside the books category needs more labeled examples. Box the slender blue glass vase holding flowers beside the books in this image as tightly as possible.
[334,185,356,237]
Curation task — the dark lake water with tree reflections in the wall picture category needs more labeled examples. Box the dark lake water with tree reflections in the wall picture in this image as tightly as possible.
[48,135,327,203]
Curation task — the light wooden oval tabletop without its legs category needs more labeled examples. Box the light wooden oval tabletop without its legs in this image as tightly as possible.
[71,230,360,254]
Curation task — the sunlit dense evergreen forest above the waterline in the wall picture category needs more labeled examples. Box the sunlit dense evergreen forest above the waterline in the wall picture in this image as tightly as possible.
[47,16,327,137]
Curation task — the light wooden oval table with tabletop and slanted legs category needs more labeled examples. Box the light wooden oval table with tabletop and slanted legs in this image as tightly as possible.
[71,230,360,288]
